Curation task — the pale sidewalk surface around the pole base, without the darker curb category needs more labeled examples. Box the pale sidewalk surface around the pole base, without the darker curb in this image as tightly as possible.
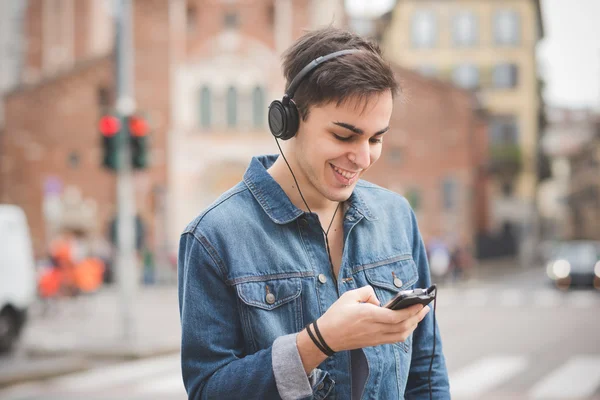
[21,286,181,359]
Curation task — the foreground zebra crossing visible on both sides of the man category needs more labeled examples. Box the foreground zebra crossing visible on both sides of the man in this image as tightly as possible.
[0,354,600,400]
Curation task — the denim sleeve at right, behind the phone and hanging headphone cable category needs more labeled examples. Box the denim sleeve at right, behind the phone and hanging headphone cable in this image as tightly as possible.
[405,205,450,400]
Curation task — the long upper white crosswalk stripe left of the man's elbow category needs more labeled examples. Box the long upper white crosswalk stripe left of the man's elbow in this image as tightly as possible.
[52,354,180,391]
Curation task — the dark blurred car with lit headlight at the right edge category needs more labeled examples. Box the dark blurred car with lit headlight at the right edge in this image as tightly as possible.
[546,240,600,289]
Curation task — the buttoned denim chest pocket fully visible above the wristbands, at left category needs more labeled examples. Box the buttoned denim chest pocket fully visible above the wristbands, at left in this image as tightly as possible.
[236,277,302,351]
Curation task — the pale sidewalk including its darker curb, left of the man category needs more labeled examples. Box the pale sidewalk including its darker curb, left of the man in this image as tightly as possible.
[0,285,181,387]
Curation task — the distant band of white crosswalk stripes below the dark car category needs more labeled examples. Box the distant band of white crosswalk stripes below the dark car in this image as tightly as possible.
[438,286,600,309]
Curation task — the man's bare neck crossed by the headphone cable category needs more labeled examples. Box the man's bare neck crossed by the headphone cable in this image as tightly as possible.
[267,157,338,214]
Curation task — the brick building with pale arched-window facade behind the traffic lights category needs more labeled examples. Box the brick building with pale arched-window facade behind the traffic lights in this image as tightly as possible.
[0,0,344,256]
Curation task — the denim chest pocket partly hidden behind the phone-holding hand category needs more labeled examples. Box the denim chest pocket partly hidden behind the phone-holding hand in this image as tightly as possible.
[363,255,418,352]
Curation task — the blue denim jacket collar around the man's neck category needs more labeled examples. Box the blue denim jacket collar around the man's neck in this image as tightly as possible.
[244,154,377,224]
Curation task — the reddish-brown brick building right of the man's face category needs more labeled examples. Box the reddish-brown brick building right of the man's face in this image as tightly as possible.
[366,67,490,252]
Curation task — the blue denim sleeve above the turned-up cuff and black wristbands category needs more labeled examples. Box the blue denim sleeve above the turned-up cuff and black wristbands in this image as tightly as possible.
[178,232,280,400]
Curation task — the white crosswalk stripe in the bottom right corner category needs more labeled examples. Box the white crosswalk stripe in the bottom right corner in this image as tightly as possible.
[531,356,600,399]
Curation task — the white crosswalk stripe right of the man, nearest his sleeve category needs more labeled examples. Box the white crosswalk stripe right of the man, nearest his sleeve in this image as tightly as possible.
[450,356,527,398]
